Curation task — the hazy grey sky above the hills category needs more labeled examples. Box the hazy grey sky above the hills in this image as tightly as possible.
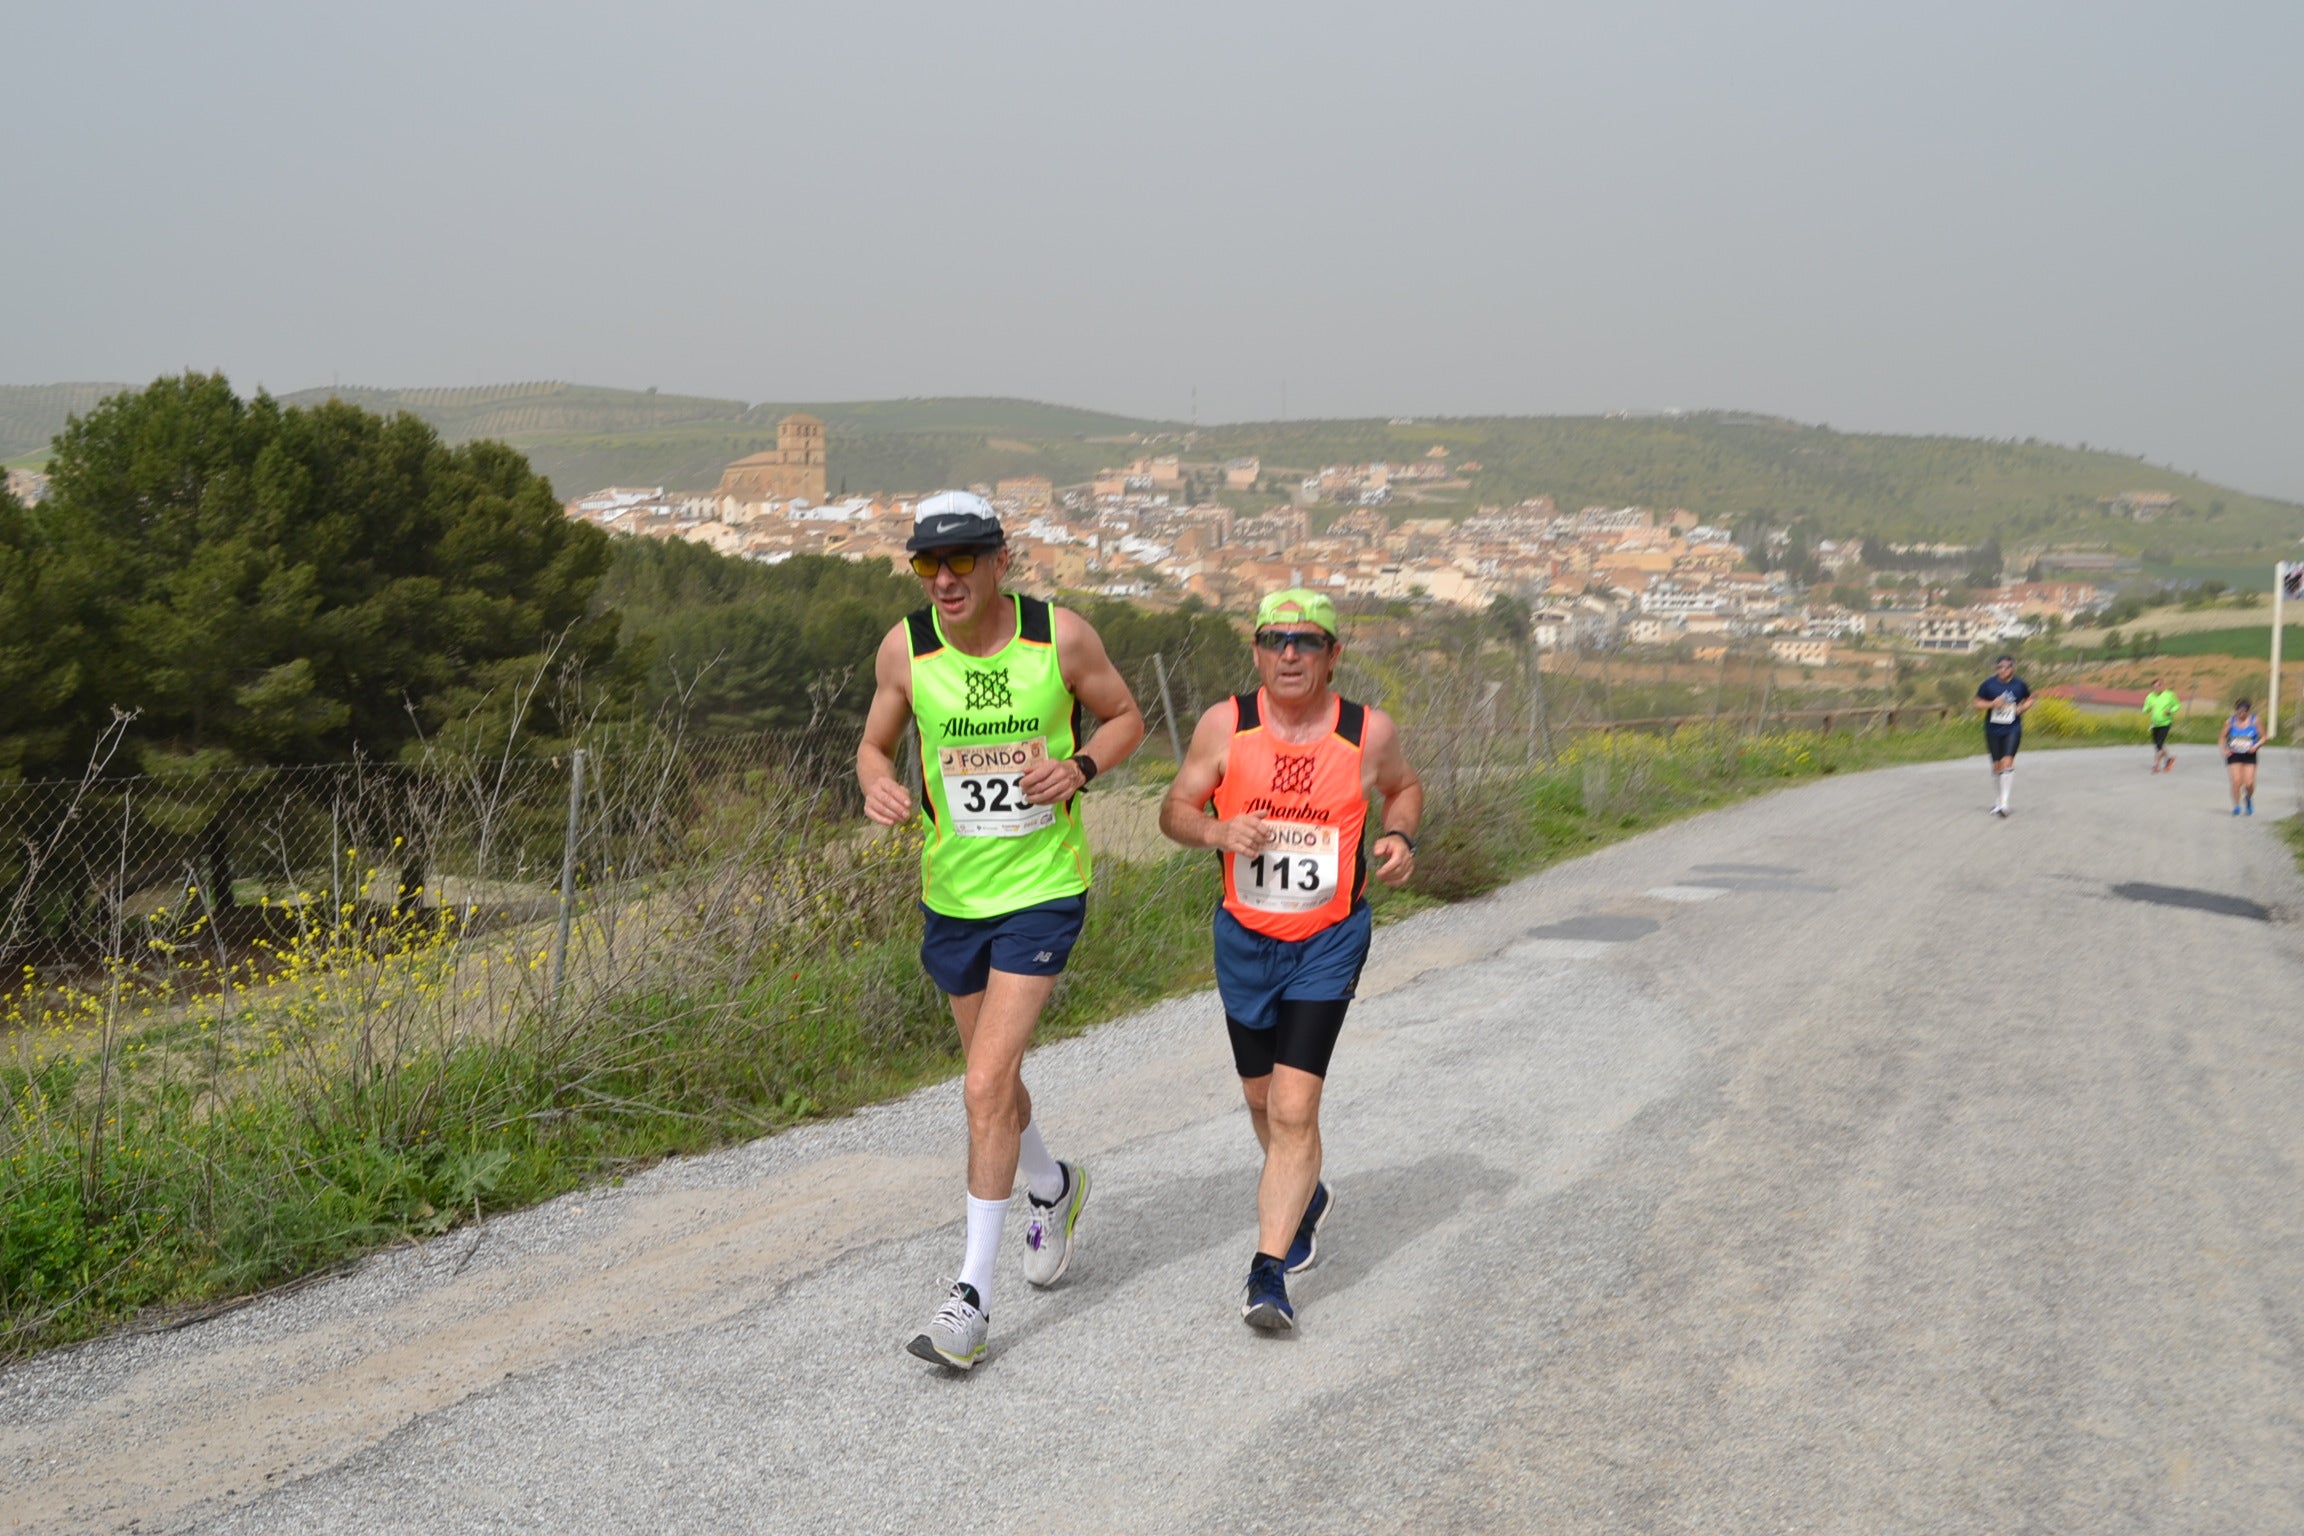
[0,0,2304,497]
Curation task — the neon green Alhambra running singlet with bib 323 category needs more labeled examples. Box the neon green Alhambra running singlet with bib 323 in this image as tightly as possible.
[905,592,1087,917]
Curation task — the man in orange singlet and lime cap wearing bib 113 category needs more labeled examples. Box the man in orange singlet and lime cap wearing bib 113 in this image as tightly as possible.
[1159,587,1424,1331]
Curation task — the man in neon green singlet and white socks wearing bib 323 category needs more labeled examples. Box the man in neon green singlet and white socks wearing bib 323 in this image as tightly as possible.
[857,491,1145,1370]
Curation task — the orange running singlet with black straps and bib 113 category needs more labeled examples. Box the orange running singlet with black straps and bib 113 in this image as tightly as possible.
[1210,691,1369,942]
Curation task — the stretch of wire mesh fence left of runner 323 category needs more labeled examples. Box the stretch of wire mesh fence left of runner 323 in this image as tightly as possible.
[0,730,852,990]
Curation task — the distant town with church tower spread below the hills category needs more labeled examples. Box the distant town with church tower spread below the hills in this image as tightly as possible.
[552,415,2108,666]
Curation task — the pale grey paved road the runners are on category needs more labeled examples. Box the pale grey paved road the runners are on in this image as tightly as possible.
[0,748,2304,1536]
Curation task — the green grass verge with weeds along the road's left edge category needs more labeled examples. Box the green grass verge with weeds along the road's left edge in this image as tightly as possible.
[0,713,2018,1356]
